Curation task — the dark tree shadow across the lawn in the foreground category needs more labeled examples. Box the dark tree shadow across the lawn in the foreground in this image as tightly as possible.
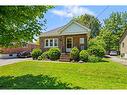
[0,74,81,89]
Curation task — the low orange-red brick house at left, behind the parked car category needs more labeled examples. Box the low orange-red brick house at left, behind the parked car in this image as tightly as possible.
[0,43,39,58]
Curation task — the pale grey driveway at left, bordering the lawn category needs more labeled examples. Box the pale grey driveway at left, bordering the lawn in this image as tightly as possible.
[0,58,32,66]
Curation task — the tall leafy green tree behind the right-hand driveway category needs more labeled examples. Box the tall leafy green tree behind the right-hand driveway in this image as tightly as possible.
[99,12,127,51]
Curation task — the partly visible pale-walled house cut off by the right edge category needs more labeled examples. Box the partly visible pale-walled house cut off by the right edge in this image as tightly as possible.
[120,30,127,58]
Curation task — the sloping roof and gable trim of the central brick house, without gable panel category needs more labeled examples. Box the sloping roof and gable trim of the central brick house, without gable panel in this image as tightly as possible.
[40,21,90,37]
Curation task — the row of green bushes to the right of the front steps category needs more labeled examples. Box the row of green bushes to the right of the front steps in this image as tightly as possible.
[70,45,105,62]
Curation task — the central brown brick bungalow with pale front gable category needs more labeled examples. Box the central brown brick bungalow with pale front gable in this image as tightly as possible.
[39,21,90,53]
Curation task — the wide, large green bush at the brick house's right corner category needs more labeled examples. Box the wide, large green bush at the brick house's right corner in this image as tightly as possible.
[88,45,105,58]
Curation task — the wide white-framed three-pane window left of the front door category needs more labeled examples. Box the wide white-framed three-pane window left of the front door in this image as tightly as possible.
[45,38,58,47]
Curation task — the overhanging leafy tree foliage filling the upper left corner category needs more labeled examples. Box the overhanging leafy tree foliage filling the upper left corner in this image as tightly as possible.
[0,6,52,47]
